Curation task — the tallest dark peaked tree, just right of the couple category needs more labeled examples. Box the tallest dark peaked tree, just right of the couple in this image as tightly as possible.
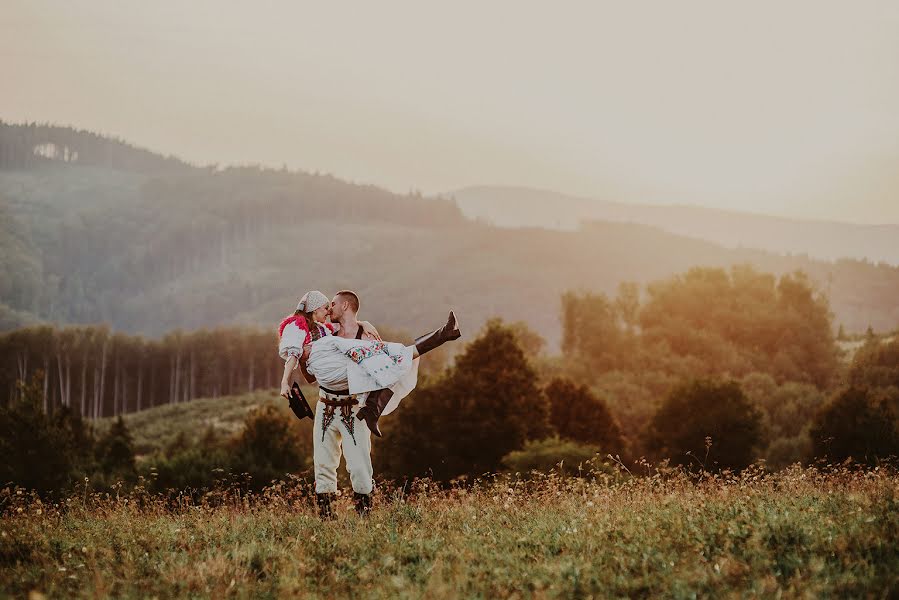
[375,320,551,481]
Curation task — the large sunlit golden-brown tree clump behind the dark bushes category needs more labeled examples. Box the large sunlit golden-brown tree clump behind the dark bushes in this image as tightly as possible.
[562,265,838,389]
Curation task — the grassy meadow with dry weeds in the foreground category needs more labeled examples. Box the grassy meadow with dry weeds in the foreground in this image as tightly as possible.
[0,467,899,598]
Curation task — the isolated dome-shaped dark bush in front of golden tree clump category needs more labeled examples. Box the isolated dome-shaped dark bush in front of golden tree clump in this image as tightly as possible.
[650,379,763,469]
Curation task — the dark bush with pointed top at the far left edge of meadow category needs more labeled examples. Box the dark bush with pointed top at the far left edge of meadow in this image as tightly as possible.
[0,372,92,492]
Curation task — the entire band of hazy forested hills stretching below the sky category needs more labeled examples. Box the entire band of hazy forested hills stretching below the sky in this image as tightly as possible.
[0,126,899,347]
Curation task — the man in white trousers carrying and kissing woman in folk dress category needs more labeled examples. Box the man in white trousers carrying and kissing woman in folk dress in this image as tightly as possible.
[278,290,461,519]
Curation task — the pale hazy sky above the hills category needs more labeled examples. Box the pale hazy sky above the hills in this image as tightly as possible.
[0,0,899,223]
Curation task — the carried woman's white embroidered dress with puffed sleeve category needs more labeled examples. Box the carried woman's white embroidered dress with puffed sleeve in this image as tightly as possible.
[278,323,418,416]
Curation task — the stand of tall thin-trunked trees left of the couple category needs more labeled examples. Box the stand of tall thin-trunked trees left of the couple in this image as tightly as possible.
[0,325,283,419]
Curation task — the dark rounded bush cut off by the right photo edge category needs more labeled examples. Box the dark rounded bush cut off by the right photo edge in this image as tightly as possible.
[812,387,899,464]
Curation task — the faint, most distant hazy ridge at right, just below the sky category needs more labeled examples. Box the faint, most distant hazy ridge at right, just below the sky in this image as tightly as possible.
[448,186,899,265]
